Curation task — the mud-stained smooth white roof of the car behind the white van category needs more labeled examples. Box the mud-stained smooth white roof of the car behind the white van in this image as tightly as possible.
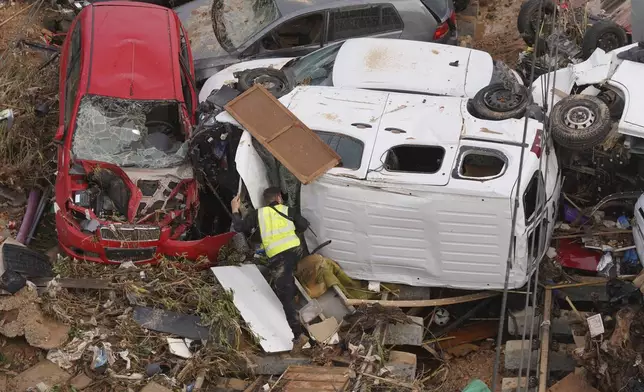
[333,38,494,97]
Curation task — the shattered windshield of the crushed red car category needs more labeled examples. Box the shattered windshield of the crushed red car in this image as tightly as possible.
[72,95,187,169]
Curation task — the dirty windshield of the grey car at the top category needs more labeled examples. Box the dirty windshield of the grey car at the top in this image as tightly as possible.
[212,0,280,52]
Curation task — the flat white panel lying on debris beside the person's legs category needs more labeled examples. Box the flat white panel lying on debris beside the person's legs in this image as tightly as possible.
[211,264,293,353]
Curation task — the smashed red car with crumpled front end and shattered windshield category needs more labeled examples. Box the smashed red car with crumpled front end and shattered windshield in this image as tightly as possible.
[54,1,233,263]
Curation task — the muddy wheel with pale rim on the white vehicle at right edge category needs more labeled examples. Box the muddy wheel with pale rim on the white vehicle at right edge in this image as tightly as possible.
[550,95,612,150]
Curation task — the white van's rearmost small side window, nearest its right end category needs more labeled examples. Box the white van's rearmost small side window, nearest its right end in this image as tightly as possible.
[458,147,507,180]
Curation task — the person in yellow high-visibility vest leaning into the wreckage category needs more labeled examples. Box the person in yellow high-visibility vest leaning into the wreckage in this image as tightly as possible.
[230,187,309,351]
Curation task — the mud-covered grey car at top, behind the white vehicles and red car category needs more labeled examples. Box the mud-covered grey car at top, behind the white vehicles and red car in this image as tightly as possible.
[175,0,456,81]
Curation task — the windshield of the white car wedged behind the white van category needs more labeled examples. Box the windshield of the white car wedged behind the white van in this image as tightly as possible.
[284,44,342,86]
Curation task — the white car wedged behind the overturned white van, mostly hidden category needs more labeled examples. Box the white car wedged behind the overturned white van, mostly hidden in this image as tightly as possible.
[199,38,529,120]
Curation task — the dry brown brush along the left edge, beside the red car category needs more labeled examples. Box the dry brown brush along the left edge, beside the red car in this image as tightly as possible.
[0,1,58,188]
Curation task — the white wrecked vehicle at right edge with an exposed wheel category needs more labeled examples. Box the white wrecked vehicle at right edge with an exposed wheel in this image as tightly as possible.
[532,44,644,151]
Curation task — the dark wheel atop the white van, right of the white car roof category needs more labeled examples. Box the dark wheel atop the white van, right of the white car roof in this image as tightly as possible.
[471,82,530,120]
